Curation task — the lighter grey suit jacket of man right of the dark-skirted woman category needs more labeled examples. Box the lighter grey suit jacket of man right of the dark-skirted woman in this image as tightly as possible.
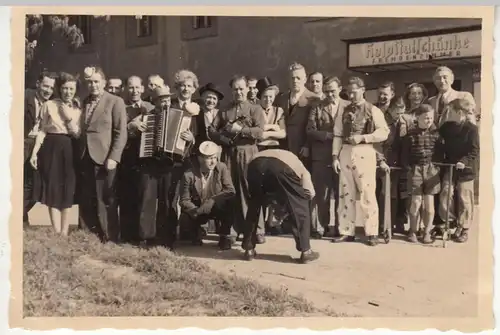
[79,92,127,164]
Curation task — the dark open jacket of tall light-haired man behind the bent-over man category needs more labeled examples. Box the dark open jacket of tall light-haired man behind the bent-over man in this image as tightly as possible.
[276,89,320,155]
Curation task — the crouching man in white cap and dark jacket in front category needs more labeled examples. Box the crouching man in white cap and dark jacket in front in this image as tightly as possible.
[180,141,235,248]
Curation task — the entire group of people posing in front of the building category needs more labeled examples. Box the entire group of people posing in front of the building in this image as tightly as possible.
[23,63,479,263]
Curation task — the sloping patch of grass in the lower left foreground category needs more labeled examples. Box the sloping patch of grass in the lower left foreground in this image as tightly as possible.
[23,227,335,317]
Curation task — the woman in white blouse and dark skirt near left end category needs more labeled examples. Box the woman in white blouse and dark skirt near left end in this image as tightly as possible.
[30,73,82,236]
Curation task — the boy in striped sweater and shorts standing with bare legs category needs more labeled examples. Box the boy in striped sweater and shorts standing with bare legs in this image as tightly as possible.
[401,104,443,244]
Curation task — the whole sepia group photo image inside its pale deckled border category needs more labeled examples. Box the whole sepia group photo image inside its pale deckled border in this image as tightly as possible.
[11,7,493,330]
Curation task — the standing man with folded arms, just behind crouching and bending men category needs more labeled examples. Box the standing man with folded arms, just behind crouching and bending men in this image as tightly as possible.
[218,75,266,249]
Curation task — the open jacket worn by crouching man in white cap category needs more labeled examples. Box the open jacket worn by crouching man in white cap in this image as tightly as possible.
[179,161,236,212]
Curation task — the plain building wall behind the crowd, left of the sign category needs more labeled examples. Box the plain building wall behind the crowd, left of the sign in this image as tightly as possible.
[29,17,480,99]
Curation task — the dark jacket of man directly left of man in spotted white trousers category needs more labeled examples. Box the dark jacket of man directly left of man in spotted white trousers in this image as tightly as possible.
[306,99,350,162]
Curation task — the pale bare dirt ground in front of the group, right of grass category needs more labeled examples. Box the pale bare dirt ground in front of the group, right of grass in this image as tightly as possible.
[30,206,478,317]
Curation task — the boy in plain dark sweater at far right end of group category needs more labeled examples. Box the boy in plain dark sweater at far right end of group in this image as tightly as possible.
[439,99,479,243]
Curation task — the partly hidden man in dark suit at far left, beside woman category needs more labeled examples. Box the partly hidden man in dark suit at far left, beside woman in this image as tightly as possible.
[23,72,56,226]
